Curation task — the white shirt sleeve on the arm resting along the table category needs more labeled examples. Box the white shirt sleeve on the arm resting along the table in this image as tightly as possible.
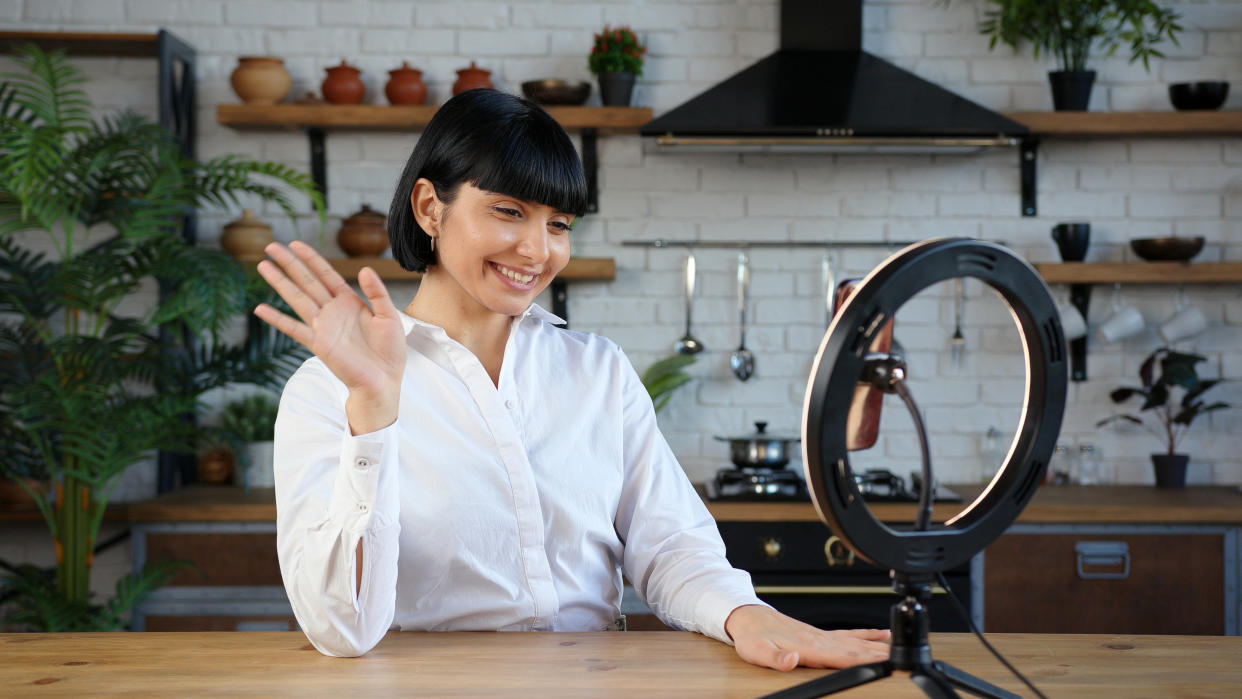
[615,350,764,643]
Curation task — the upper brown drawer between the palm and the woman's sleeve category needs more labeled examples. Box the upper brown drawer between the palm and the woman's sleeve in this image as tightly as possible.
[147,531,282,587]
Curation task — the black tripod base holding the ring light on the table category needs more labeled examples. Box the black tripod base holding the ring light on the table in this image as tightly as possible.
[763,571,1021,699]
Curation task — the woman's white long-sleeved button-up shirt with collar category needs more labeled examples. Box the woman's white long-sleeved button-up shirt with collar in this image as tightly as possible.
[274,305,761,656]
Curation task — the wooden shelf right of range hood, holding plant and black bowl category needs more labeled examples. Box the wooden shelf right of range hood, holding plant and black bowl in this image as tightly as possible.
[1005,110,1242,138]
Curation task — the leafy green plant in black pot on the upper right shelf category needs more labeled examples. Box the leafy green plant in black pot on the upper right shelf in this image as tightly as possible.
[979,0,1181,112]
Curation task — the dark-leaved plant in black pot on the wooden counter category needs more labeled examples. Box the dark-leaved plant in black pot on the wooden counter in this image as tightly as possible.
[1095,348,1230,488]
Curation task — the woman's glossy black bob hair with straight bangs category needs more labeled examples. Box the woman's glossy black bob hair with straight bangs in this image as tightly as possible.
[388,89,586,272]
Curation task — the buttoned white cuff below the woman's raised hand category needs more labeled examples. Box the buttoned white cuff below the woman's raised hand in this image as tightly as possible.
[330,423,399,533]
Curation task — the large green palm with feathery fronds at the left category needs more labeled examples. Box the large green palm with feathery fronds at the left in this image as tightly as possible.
[0,46,324,631]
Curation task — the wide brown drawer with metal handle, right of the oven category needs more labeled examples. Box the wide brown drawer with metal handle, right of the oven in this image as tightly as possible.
[984,533,1225,634]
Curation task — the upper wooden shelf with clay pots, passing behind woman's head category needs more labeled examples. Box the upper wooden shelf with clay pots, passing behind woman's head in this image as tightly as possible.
[216,104,651,132]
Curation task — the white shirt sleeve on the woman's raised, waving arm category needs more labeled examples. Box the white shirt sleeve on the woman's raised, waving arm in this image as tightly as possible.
[274,359,400,657]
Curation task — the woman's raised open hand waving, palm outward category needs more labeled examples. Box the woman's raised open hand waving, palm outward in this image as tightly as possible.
[255,241,406,435]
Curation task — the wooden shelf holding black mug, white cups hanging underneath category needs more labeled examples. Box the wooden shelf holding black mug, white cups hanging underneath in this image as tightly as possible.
[1035,262,1242,284]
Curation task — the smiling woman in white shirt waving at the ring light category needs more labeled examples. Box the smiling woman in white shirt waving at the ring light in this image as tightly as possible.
[255,89,888,669]
